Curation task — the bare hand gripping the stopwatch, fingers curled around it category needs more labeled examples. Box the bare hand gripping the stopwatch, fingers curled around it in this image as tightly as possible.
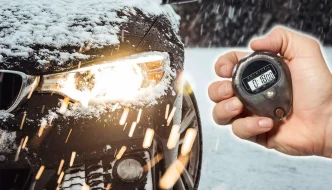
[208,26,332,158]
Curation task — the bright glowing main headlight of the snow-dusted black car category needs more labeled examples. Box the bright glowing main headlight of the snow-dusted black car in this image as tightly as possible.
[39,52,171,102]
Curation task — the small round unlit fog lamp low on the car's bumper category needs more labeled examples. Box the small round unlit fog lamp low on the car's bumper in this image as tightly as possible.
[115,158,144,182]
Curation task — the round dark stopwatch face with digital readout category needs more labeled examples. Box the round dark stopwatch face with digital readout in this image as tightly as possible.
[242,61,278,94]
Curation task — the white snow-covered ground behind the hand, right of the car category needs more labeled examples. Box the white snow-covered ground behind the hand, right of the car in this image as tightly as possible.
[185,48,332,190]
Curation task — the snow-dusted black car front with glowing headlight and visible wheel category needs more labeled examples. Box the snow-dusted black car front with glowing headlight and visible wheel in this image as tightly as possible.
[0,0,202,190]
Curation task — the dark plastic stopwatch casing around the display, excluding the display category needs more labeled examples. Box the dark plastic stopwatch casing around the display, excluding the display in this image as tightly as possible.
[232,52,293,121]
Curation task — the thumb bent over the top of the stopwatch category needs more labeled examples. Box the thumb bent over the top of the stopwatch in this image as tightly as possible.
[250,26,320,60]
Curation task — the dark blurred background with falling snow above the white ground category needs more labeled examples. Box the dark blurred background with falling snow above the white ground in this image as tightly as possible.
[174,0,332,47]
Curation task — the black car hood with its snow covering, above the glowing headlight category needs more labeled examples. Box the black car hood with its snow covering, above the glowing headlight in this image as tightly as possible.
[0,0,183,75]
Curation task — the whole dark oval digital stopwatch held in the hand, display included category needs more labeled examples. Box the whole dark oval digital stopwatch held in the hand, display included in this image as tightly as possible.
[232,52,293,120]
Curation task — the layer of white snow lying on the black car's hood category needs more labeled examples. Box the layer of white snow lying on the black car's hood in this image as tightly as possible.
[0,0,179,67]
